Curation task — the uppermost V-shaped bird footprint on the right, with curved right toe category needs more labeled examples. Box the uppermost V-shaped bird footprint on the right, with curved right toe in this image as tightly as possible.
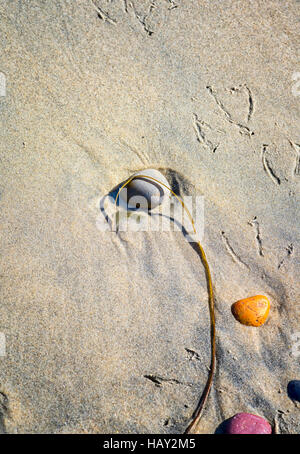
[206,85,254,137]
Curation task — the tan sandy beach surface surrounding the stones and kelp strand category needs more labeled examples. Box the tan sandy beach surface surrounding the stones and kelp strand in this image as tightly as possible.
[0,0,300,434]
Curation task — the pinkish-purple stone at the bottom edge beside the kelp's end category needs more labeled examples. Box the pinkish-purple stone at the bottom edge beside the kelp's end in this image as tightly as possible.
[226,413,272,435]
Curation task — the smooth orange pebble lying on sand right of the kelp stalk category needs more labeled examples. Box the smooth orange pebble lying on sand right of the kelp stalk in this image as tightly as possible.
[231,295,270,326]
